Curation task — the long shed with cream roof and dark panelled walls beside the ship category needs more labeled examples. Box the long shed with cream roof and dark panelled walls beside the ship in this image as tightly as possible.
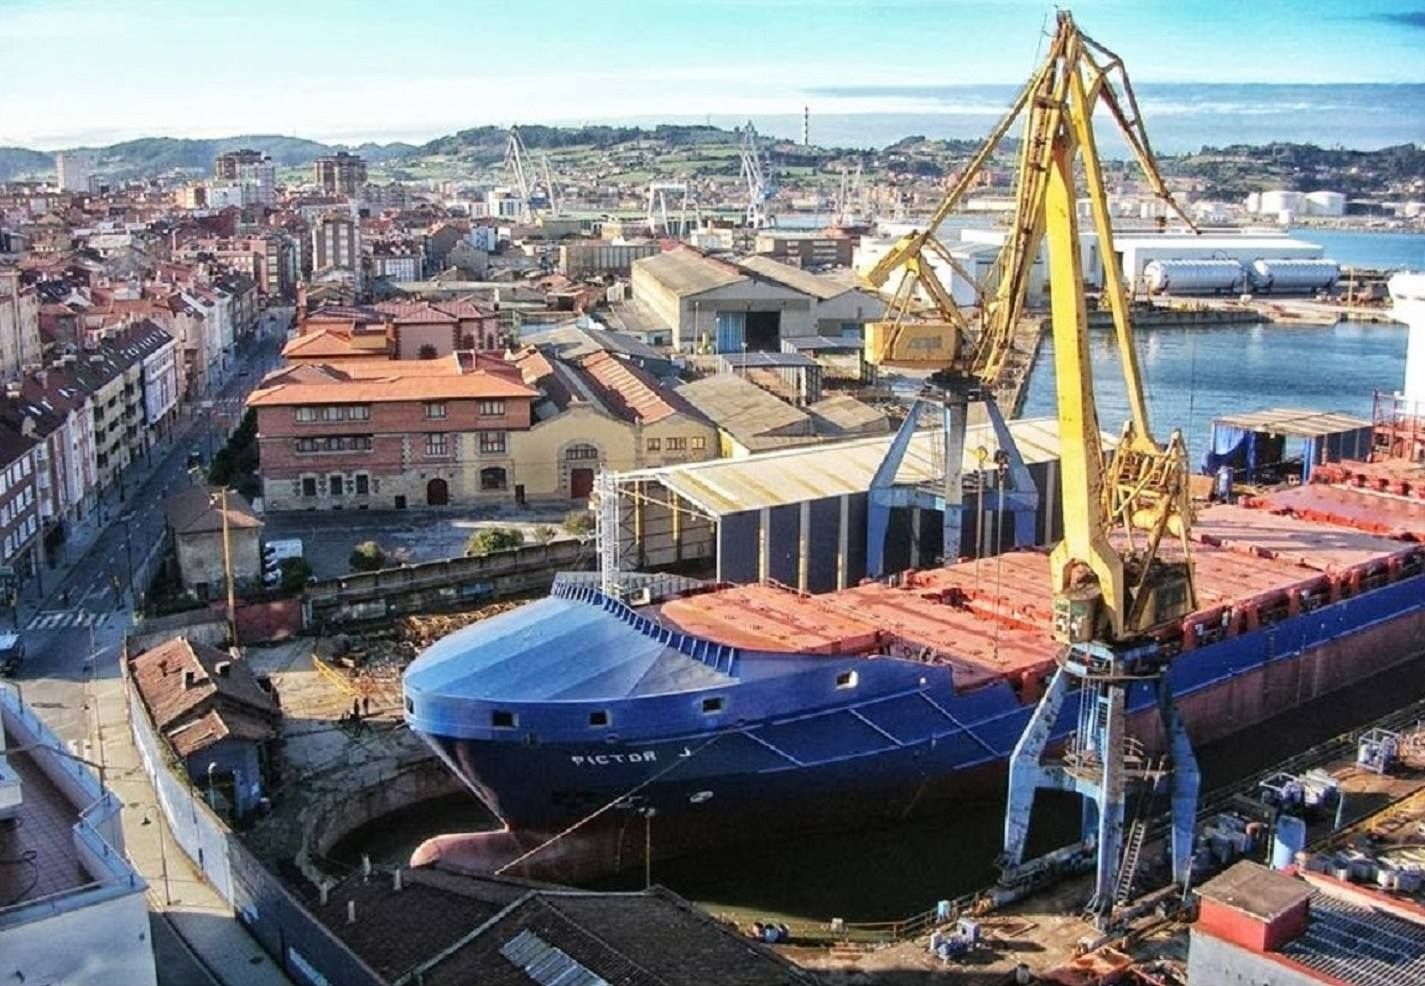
[614,419,1083,593]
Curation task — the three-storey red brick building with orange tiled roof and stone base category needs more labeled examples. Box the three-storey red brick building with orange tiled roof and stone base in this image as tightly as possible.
[248,353,539,510]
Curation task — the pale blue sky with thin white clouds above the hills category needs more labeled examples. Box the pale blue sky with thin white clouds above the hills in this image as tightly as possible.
[0,0,1425,148]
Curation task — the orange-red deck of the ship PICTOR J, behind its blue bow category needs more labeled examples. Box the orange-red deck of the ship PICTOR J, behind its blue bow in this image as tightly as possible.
[660,484,1425,690]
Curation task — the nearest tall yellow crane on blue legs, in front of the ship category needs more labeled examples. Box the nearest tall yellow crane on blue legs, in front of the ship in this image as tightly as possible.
[956,11,1198,925]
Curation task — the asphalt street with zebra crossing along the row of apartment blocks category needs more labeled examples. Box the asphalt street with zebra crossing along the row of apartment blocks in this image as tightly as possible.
[16,308,291,745]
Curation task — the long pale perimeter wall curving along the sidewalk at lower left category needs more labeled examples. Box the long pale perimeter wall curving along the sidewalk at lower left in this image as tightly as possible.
[120,660,385,986]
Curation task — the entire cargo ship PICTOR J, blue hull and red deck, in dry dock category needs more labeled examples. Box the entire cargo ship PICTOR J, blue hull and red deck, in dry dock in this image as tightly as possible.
[405,473,1425,881]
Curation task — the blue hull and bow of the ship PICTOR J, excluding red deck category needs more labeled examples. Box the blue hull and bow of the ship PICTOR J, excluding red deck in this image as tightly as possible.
[405,574,1425,876]
